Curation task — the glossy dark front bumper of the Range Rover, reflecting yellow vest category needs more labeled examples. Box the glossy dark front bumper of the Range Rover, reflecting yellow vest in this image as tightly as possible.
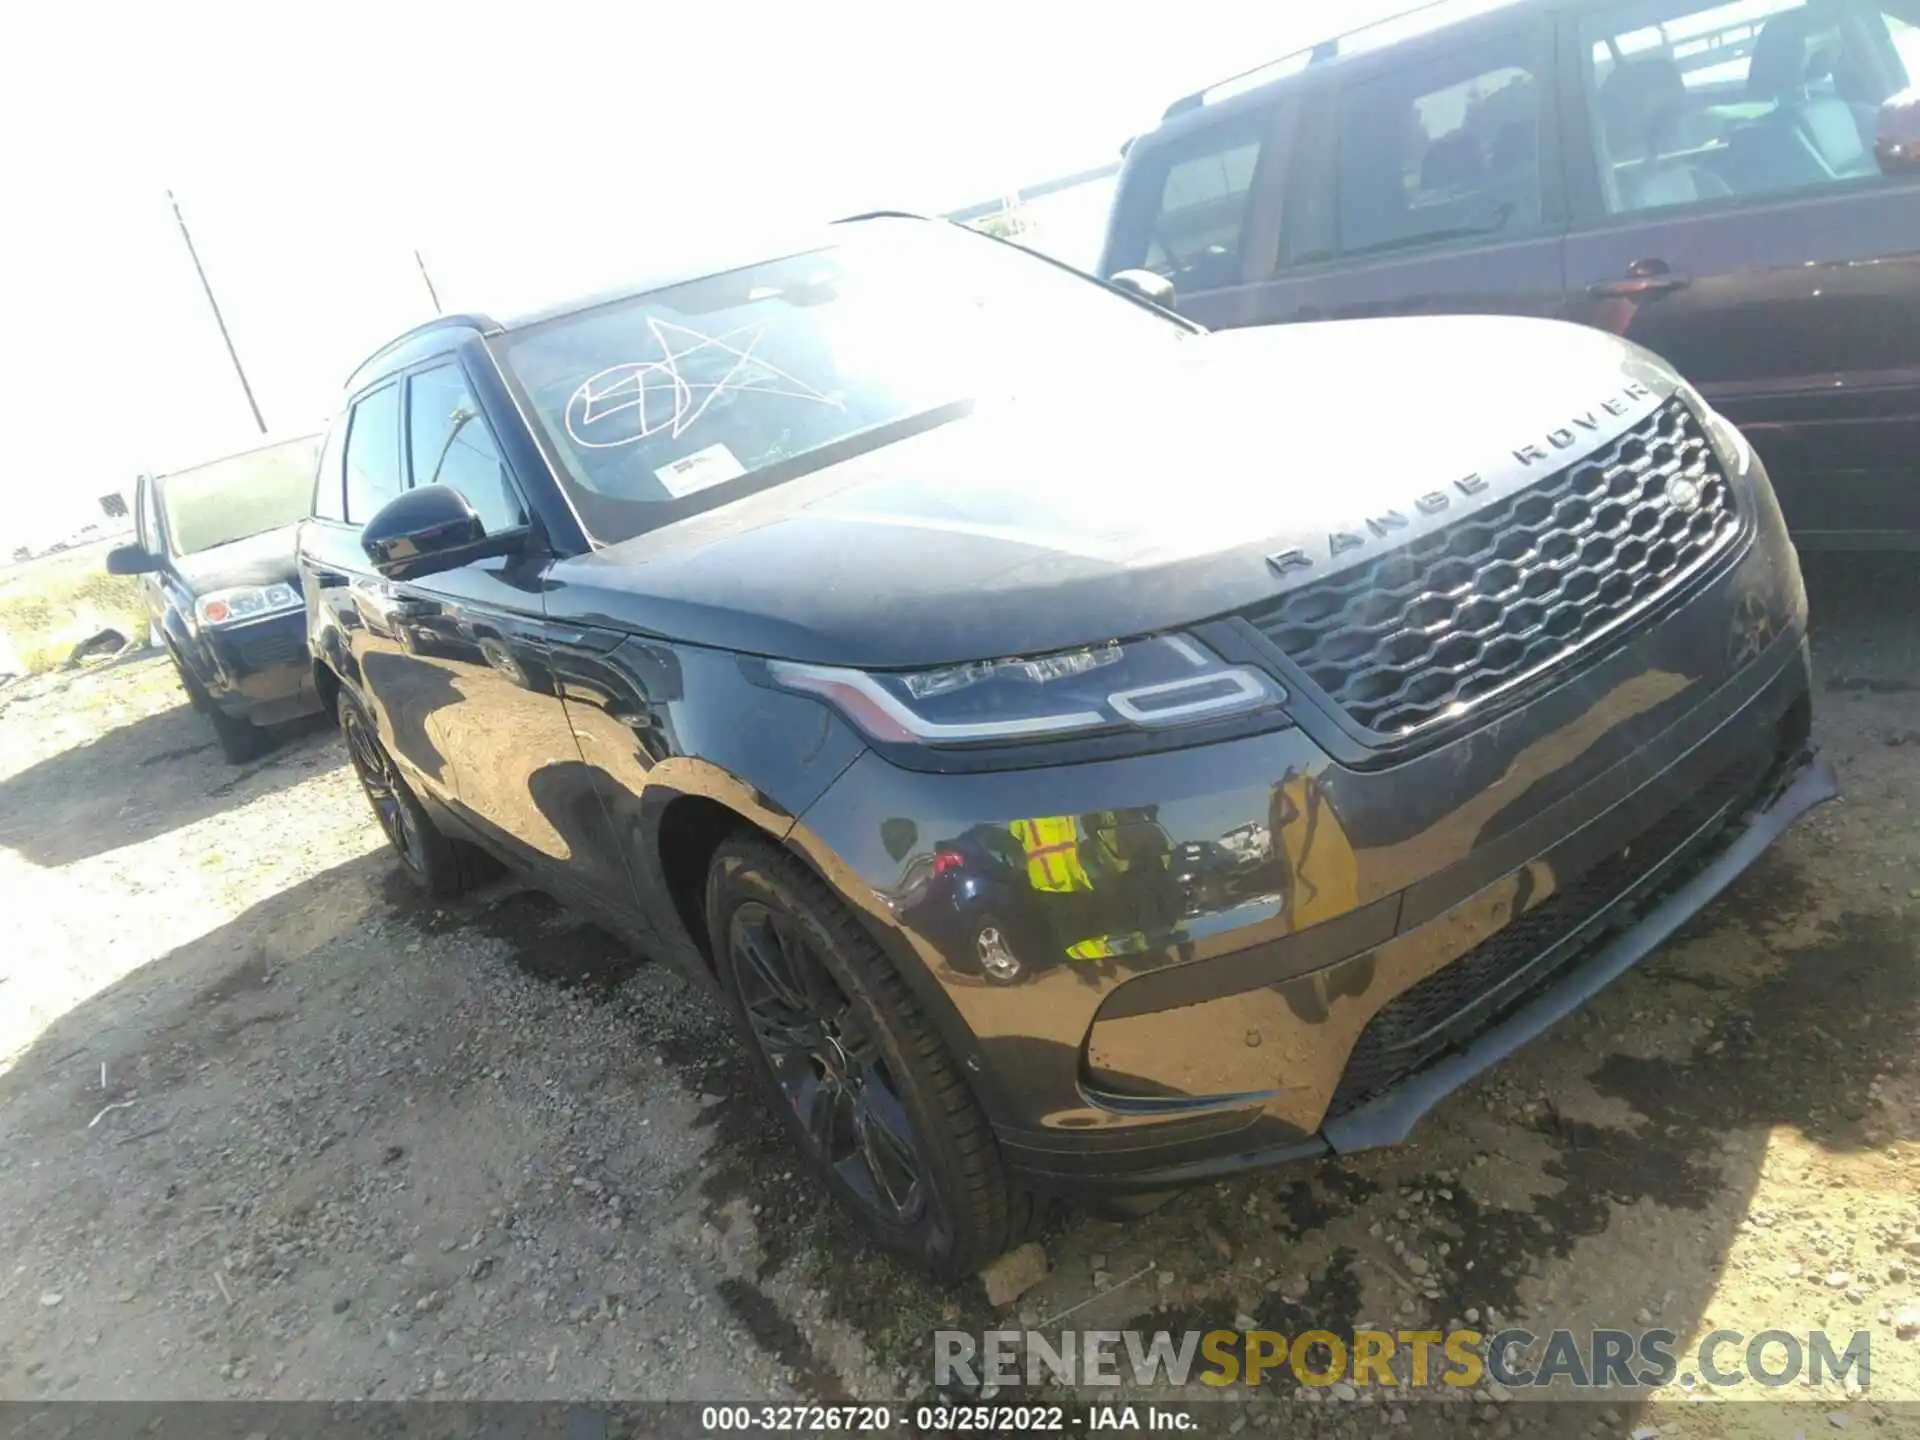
[789,468,1834,1190]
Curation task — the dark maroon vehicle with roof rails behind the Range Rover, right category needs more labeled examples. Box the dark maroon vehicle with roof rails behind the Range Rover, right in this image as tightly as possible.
[1100,0,1920,547]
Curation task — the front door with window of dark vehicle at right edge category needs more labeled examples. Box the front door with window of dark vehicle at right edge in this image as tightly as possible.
[1563,0,1920,545]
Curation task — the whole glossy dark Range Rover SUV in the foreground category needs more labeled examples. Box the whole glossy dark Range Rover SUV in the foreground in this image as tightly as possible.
[300,217,1834,1275]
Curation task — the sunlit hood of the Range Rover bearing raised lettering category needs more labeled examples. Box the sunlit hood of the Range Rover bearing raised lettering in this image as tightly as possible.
[549,317,1680,668]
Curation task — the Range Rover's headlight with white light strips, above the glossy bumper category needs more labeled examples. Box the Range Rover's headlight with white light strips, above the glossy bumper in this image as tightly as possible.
[768,636,1286,745]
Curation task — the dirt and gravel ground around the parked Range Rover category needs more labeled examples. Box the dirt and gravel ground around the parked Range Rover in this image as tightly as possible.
[0,557,1920,1438]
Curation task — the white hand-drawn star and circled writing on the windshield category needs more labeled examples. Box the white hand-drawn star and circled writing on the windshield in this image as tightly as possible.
[566,315,845,449]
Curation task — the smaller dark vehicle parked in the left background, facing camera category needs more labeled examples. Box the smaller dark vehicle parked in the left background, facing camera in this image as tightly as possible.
[108,436,321,764]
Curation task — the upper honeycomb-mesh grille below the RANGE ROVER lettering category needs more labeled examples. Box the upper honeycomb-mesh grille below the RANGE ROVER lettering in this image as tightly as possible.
[1248,399,1738,737]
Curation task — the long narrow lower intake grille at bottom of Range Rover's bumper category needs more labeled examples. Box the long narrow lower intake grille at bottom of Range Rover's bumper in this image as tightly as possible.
[1327,710,1807,1117]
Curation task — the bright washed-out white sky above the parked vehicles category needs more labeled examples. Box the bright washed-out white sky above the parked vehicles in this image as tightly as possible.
[0,0,1405,551]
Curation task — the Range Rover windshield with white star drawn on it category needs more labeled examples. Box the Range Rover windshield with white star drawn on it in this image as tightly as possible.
[493,221,1192,540]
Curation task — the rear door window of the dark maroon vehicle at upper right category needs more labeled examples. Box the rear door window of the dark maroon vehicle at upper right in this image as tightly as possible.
[1336,27,1549,255]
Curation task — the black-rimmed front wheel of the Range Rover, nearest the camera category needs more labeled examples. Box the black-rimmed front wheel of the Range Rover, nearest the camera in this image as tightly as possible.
[707,835,1035,1281]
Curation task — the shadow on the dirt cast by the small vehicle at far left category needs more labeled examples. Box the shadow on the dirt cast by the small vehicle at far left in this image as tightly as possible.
[0,699,344,870]
